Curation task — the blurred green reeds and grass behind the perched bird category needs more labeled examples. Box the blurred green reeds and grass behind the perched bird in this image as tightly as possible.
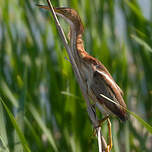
[0,0,152,152]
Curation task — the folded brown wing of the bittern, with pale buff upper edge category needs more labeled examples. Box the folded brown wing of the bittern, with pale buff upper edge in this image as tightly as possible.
[90,70,127,121]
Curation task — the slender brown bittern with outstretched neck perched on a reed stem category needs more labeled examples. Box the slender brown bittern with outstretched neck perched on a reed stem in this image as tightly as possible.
[38,5,127,151]
